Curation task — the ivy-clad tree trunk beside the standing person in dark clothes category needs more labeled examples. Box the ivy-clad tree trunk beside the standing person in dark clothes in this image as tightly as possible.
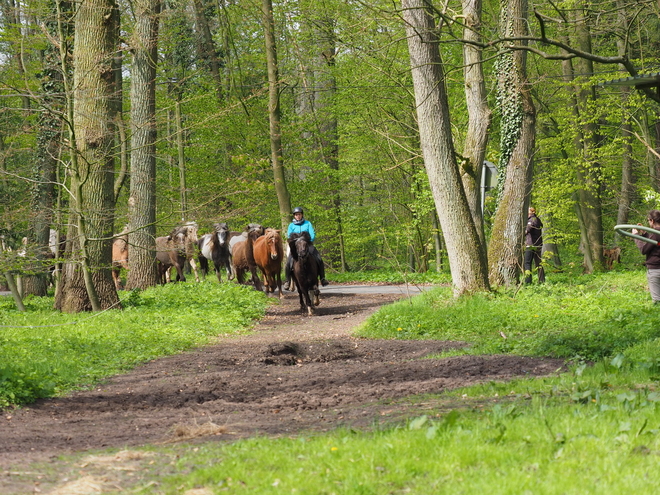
[488,0,536,285]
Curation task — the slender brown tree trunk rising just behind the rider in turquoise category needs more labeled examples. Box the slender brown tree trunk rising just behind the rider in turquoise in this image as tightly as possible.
[262,0,291,232]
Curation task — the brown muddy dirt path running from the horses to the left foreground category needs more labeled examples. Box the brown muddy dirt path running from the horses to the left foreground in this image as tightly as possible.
[0,293,562,491]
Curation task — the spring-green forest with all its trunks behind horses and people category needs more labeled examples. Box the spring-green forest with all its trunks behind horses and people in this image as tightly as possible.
[0,0,660,311]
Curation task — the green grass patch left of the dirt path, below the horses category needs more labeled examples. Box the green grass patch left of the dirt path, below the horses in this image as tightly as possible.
[0,282,267,407]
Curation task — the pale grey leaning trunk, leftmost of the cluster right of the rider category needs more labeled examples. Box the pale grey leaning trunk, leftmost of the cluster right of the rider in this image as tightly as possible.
[403,0,489,295]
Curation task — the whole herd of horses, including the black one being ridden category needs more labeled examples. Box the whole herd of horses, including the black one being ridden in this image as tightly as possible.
[112,222,319,315]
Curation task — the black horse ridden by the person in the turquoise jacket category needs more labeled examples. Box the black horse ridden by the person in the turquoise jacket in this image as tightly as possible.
[288,232,320,316]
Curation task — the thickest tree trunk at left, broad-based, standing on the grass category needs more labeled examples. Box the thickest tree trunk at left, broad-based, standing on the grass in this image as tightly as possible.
[56,0,119,312]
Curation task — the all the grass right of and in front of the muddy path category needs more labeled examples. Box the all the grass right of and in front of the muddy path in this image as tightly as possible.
[6,270,660,494]
